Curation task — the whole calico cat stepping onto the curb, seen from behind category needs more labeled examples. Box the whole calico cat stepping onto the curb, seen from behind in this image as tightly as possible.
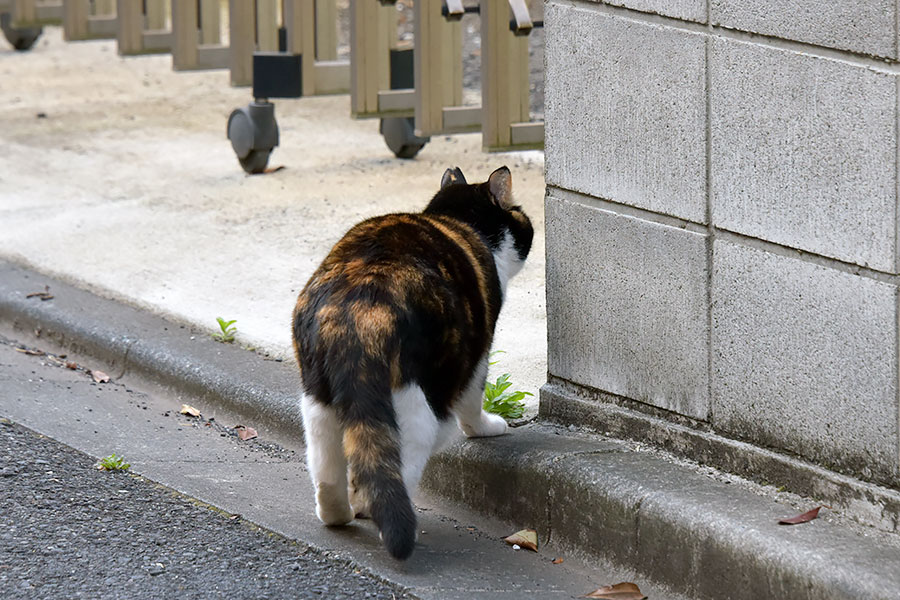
[293,167,534,559]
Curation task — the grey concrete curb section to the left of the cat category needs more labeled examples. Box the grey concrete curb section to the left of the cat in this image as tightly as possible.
[0,261,302,431]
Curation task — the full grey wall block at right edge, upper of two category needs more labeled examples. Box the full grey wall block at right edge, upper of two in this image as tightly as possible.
[712,37,897,272]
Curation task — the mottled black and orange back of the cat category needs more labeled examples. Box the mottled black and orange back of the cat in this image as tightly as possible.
[293,214,501,395]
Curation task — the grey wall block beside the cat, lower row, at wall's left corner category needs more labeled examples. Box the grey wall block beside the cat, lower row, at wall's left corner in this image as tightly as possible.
[546,190,708,419]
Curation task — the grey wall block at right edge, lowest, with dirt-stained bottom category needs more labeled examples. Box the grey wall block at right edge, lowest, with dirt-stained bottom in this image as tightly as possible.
[711,240,898,483]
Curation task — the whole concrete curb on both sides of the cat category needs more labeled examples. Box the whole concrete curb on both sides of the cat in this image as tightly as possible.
[0,263,900,600]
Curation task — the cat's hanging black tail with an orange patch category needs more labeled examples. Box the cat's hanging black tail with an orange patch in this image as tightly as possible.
[344,410,416,560]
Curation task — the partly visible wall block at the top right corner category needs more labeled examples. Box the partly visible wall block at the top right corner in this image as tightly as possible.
[709,0,897,58]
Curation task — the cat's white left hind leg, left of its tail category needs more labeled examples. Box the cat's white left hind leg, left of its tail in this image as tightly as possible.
[300,395,353,525]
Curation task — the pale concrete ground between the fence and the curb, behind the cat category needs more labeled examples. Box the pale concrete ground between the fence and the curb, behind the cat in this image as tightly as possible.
[0,27,547,413]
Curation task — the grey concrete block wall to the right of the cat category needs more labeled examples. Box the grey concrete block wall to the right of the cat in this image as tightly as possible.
[545,0,900,488]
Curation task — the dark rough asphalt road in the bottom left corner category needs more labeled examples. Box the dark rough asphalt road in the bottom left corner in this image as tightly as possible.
[0,396,408,599]
